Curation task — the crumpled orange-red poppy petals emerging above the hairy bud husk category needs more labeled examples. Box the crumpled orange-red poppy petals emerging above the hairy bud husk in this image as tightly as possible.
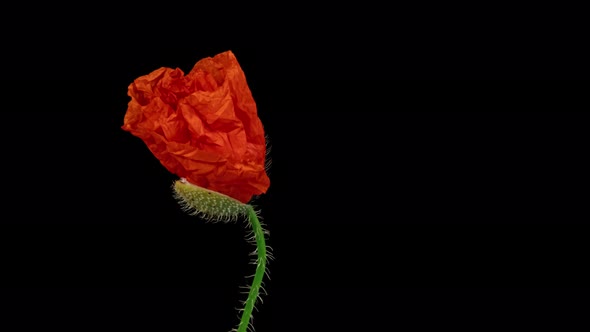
[122,51,270,203]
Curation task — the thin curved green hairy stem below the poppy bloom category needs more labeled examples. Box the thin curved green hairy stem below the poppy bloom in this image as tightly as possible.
[238,205,266,332]
